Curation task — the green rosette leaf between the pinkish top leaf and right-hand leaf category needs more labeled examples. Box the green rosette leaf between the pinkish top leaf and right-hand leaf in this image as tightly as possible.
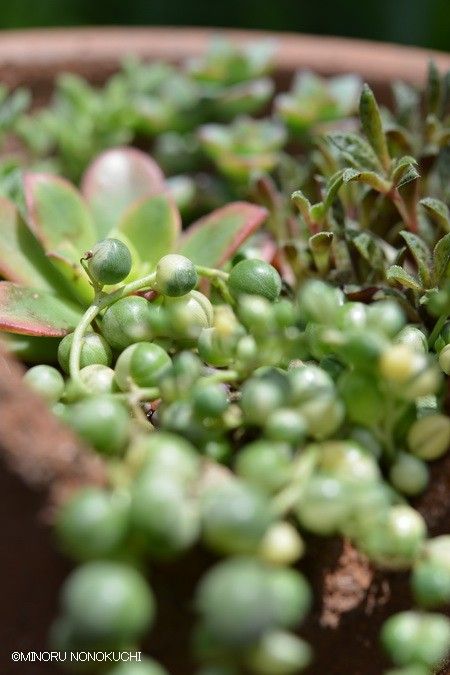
[118,194,181,269]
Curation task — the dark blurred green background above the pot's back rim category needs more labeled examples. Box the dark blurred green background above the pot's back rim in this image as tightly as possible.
[0,0,450,51]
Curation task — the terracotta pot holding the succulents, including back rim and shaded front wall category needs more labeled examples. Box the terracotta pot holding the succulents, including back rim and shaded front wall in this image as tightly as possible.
[0,28,450,675]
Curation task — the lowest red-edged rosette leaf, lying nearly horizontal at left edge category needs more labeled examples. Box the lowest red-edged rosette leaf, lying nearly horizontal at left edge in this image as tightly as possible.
[0,281,82,337]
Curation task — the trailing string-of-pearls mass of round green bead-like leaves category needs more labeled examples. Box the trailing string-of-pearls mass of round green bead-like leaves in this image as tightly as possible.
[25,244,450,675]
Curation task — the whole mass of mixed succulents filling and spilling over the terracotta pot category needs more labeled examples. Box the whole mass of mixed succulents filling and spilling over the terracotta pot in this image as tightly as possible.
[0,27,450,675]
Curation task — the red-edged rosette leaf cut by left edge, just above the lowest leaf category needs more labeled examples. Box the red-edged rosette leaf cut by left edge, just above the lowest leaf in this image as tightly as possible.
[0,197,70,293]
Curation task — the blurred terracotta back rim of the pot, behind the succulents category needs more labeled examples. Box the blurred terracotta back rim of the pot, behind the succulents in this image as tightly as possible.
[0,27,450,93]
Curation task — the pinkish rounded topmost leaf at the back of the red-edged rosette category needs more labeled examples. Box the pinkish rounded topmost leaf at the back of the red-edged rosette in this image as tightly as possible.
[81,148,165,239]
